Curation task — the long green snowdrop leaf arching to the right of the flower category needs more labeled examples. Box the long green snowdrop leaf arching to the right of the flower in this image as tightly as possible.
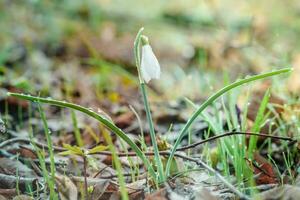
[166,68,291,176]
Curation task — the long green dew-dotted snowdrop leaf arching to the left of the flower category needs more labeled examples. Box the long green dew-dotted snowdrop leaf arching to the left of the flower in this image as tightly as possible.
[7,92,156,178]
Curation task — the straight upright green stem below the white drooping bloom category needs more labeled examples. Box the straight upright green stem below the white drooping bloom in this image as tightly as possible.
[140,83,165,183]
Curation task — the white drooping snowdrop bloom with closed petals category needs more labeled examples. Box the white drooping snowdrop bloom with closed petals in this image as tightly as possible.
[141,44,160,83]
